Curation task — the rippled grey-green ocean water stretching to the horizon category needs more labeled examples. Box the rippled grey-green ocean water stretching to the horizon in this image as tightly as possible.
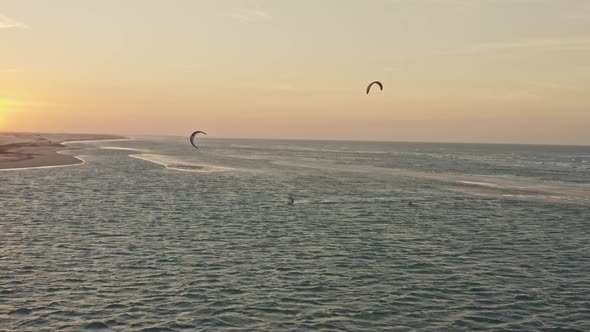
[0,137,590,331]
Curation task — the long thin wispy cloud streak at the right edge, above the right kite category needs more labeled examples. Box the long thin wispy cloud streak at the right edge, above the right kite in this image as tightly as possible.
[439,38,590,55]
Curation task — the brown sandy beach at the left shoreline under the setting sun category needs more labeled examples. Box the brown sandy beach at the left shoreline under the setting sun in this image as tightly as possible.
[0,133,125,170]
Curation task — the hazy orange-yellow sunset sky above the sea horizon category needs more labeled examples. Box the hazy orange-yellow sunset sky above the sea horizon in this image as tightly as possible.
[0,0,590,145]
